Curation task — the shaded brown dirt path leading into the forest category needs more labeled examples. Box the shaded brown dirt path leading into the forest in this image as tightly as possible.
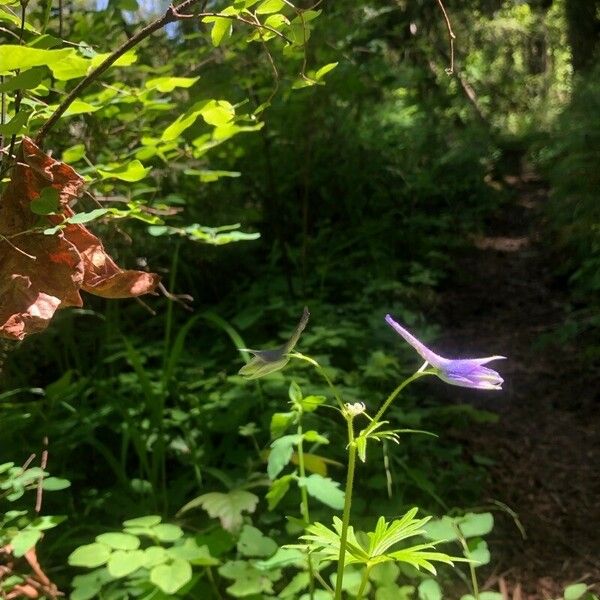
[440,169,600,600]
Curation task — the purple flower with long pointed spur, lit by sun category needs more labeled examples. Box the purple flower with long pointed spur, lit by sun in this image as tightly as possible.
[385,315,506,390]
